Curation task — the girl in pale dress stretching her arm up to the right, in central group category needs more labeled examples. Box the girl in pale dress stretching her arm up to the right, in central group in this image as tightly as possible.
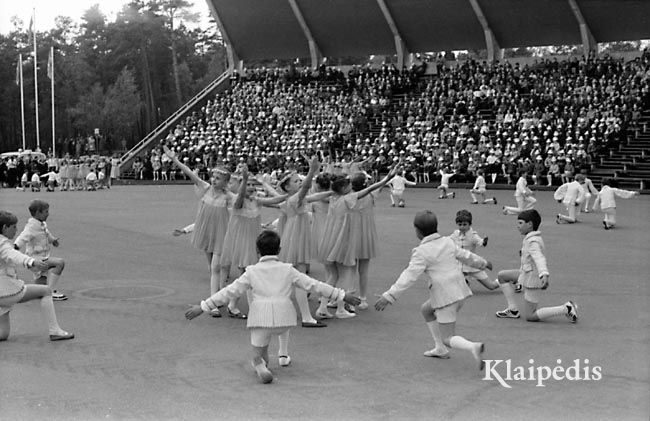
[316,166,398,319]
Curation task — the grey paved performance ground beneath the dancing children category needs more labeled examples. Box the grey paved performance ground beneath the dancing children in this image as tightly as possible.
[0,185,650,420]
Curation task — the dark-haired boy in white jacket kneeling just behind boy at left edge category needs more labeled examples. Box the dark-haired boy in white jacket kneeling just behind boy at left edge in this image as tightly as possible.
[15,199,68,301]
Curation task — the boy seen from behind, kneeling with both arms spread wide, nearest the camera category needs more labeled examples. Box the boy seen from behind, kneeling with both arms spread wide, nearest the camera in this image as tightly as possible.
[185,231,359,383]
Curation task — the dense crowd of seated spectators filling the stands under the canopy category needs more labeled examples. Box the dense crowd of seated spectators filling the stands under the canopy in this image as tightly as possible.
[129,52,650,184]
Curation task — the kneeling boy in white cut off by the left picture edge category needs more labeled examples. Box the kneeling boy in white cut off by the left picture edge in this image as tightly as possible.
[0,211,74,341]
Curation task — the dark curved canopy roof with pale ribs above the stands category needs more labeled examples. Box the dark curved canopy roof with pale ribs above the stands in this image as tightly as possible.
[206,0,650,60]
